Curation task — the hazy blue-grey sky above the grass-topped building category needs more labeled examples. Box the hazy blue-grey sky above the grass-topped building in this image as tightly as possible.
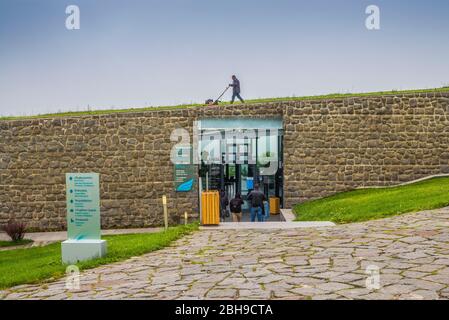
[0,0,449,116]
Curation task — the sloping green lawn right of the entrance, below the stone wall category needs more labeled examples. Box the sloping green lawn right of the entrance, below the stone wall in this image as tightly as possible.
[293,177,449,223]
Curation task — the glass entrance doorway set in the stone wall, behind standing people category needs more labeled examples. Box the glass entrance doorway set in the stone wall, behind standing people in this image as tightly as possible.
[198,119,284,222]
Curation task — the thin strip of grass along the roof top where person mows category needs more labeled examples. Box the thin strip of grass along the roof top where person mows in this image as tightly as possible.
[0,87,449,120]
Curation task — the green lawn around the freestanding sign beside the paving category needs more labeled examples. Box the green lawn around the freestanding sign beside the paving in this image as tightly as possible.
[0,224,198,289]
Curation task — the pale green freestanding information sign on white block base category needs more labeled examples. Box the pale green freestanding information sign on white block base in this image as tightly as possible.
[61,173,107,264]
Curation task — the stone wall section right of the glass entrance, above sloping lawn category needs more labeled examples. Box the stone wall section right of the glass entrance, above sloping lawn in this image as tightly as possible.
[284,93,449,206]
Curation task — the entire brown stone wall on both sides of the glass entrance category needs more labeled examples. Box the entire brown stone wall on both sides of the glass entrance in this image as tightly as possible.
[0,93,449,230]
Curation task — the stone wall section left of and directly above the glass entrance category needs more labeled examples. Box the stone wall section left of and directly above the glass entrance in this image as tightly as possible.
[0,105,282,230]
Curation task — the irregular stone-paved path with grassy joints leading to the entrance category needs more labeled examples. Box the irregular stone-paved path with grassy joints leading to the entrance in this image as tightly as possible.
[0,208,449,299]
